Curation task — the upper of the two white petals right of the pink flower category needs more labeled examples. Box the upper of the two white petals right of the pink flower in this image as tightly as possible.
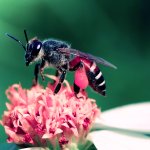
[96,102,150,133]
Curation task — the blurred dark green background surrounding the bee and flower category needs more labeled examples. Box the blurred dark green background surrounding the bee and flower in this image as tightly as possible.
[0,0,150,143]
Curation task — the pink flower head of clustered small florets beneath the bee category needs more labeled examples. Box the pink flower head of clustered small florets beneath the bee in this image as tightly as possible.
[2,76,100,147]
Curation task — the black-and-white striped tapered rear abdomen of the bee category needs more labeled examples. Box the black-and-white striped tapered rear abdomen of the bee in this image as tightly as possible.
[87,62,106,96]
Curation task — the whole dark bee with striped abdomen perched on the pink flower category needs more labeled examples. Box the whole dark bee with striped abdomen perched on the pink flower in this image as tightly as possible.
[6,30,116,96]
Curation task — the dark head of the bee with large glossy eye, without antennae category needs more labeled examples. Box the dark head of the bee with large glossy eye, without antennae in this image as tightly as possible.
[25,38,42,66]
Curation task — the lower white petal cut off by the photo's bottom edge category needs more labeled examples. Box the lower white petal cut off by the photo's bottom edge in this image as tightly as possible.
[88,130,150,150]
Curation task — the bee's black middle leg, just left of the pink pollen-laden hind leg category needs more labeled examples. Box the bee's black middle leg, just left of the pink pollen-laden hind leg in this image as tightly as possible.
[54,69,66,94]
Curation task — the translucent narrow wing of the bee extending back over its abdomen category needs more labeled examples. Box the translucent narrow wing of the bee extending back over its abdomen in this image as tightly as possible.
[60,48,117,69]
